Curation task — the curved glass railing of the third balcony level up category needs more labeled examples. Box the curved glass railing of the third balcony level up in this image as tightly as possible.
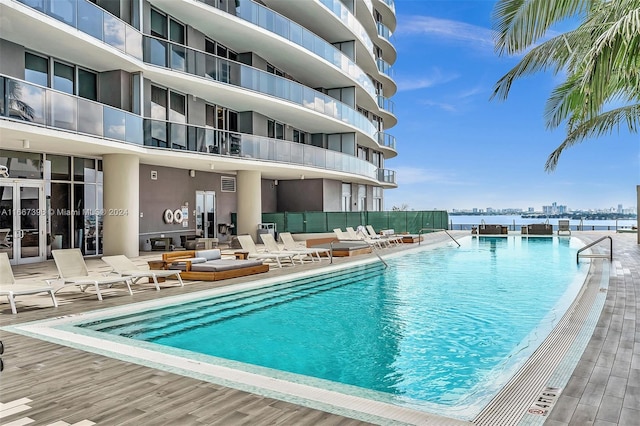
[212,0,375,98]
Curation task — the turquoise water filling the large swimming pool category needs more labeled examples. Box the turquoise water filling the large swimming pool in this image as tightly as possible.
[81,237,588,418]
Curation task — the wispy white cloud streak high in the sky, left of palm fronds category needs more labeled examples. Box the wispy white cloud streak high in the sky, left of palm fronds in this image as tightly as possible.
[396,16,493,49]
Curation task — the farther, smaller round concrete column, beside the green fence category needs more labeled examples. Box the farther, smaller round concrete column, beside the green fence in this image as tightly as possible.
[237,170,262,243]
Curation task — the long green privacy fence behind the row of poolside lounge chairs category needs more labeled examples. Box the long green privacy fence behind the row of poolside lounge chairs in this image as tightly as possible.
[231,210,449,234]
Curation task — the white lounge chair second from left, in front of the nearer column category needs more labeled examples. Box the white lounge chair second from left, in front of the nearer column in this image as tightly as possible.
[47,249,133,300]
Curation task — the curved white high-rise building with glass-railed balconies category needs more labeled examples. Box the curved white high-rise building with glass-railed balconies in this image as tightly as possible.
[0,0,397,263]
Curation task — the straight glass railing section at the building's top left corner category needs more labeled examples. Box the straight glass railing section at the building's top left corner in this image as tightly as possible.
[17,0,142,59]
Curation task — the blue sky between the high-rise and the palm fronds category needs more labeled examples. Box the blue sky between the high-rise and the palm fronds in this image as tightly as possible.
[385,0,640,210]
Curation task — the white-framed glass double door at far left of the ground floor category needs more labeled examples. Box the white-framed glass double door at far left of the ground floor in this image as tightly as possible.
[0,179,47,265]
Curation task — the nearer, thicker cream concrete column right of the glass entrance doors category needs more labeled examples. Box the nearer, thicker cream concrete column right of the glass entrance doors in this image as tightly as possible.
[102,154,140,257]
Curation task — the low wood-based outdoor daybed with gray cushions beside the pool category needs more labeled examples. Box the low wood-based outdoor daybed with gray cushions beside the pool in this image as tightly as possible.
[162,249,269,281]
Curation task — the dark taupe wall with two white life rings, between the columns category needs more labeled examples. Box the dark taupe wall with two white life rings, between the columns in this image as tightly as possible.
[140,164,237,244]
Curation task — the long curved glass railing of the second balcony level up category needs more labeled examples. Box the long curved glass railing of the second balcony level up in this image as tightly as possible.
[144,36,376,137]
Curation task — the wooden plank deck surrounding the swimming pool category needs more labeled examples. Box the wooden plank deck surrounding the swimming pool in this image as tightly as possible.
[0,231,640,426]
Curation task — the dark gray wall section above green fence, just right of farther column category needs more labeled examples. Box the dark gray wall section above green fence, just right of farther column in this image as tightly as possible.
[278,179,323,212]
